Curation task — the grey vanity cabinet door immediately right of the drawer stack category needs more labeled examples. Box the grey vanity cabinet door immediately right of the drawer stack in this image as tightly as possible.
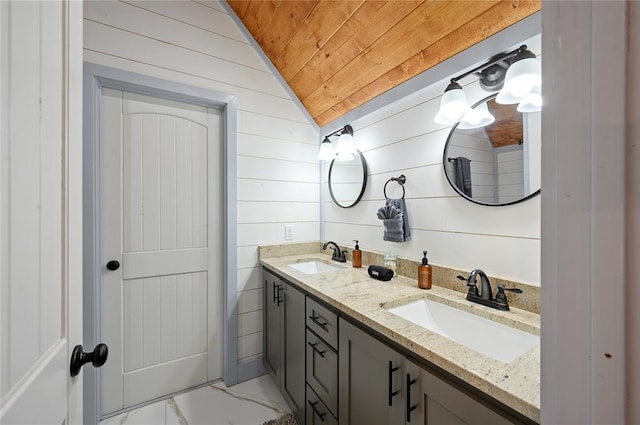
[338,319,404,425]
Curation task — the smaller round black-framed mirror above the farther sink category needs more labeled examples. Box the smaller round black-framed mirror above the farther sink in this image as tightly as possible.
[329,151,367,208]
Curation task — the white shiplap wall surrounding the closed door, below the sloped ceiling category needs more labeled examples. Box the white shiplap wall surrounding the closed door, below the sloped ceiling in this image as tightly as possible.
[84,0,319,374]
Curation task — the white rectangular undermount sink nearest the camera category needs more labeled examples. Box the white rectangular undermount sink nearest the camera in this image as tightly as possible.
[388,299,540,363]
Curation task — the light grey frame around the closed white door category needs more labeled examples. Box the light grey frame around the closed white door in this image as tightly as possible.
[83,62,238,424]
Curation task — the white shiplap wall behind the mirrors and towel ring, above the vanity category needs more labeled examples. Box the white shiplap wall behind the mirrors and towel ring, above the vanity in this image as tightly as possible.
[323,37,540,285]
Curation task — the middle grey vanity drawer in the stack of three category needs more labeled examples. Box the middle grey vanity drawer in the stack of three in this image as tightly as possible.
[306,329,338,416]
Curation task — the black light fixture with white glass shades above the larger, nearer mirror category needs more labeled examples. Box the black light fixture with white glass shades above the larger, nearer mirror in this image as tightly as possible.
[434,45,542,129]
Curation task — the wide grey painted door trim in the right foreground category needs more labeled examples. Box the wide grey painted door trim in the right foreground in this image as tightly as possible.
[541,1,637,423]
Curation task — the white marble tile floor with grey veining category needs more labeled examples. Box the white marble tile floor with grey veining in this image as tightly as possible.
[100,375,289,425]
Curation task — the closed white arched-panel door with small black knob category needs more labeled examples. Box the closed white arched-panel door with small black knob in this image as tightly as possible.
[101,88,223,414]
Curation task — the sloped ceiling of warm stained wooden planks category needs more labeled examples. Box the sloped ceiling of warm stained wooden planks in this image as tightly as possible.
[228,0,541,127]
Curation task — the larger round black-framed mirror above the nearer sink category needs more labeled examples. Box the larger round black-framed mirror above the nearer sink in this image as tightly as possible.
[442,94,541,206]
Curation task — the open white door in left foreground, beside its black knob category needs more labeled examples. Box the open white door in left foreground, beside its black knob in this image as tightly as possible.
[0,1,84,424]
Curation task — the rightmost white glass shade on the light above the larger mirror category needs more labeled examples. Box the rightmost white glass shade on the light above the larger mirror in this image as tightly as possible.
[496,58,542,105]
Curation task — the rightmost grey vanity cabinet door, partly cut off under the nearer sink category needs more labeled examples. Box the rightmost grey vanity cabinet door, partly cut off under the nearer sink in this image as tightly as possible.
[406,360,518,425]
